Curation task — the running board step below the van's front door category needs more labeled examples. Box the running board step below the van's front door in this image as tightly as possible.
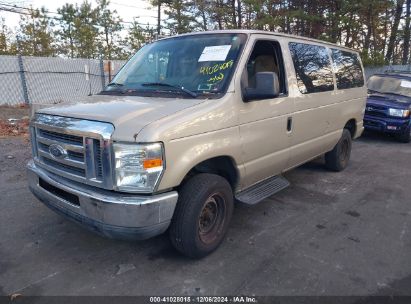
[235,175,290,205]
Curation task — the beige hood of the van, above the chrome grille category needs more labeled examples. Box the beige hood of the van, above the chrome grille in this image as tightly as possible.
[36,95,204,141]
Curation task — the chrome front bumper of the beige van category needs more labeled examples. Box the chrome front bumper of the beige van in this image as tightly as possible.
[27,161,178,240]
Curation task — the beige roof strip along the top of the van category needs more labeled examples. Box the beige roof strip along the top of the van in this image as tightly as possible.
[164,29,358,53]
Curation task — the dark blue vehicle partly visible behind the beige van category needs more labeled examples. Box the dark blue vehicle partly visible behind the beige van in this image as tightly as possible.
[364,72,411,143]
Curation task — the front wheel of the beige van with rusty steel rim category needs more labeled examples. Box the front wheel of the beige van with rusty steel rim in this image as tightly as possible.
[170,173,234,258]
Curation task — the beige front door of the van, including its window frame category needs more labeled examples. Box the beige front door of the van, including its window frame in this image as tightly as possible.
[239,35,293,188]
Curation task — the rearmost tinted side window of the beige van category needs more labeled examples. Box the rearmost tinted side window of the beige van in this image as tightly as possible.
[331,49,364,89]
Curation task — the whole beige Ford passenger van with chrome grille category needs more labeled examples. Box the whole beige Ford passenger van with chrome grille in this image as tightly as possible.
[28,30,366,258]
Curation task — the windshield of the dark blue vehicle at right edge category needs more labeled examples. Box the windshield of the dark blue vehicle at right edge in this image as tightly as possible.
[367,75,411,97]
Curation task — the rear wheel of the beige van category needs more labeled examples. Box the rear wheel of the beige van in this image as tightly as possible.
[325,129,352,172]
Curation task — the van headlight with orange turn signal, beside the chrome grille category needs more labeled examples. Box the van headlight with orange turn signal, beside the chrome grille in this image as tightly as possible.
[113,143,164,193]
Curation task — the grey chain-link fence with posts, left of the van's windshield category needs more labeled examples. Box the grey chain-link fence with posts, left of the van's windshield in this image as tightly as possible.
[0,56,125,105]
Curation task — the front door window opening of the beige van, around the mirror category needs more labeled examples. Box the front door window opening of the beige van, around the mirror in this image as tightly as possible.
[243,40,287,94]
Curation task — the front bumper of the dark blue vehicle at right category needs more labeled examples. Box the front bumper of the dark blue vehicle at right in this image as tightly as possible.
[364,115,410,134]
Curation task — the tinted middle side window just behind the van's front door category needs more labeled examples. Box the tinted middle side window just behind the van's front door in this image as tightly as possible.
[289,42,334,94]
